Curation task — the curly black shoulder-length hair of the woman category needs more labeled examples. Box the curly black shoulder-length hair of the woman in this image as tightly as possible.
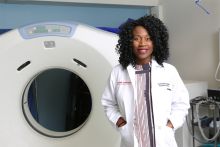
[116,15,169,68]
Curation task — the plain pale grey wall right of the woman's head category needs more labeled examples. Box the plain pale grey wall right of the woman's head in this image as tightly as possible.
[159,0,220,88]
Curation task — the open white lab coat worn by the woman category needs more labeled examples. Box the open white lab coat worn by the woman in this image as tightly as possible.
[101,60,189,147]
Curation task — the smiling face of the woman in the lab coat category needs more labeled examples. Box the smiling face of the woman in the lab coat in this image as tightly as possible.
[132,26,153,65]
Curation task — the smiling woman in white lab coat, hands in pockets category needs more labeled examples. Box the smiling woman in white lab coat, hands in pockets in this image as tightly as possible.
[101,16,189,147]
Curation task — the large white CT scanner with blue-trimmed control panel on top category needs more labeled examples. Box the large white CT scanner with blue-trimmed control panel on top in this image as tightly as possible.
[0,22,120,147]
